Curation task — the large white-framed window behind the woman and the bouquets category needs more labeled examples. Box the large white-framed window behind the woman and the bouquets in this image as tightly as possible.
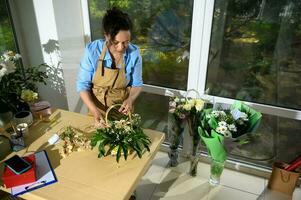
[89,0,301,170]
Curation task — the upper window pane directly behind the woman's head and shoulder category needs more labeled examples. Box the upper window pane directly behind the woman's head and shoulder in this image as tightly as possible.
[89,0,193,90]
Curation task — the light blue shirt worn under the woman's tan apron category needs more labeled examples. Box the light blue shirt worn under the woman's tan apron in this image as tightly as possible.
[76,39,143,92]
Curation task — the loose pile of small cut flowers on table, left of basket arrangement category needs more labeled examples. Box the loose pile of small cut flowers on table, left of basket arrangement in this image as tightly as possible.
[59,126,91,158]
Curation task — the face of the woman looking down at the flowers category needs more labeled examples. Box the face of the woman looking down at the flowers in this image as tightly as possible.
[105,30,131,54]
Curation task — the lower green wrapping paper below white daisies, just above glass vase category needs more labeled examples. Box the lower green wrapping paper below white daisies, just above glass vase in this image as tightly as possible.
[198,127,227,162]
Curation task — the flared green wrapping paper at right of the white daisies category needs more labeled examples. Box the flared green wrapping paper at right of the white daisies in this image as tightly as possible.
[231,101,262,138]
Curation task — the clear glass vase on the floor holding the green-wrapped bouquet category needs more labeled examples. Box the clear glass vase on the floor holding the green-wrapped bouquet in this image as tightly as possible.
[209,159,225,186]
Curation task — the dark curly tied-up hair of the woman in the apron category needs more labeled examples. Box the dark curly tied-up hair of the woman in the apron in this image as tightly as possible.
[102,7,133,39]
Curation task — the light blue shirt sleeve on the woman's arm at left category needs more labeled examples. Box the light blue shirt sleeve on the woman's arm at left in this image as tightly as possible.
[76,46,94,92]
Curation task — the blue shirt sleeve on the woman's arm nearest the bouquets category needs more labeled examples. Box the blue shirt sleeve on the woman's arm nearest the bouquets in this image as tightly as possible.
[131,50,143,87]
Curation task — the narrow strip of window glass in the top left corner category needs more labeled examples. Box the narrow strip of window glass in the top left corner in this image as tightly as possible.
[0,0,16,53]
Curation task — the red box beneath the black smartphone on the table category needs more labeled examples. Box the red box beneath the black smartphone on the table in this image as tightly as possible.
[2,154,36,188]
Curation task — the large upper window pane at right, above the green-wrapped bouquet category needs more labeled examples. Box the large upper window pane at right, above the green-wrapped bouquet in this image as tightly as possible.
[206,0,301,110]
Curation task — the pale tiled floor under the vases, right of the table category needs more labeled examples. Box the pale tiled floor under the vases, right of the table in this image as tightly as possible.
[136,152,301,200]
